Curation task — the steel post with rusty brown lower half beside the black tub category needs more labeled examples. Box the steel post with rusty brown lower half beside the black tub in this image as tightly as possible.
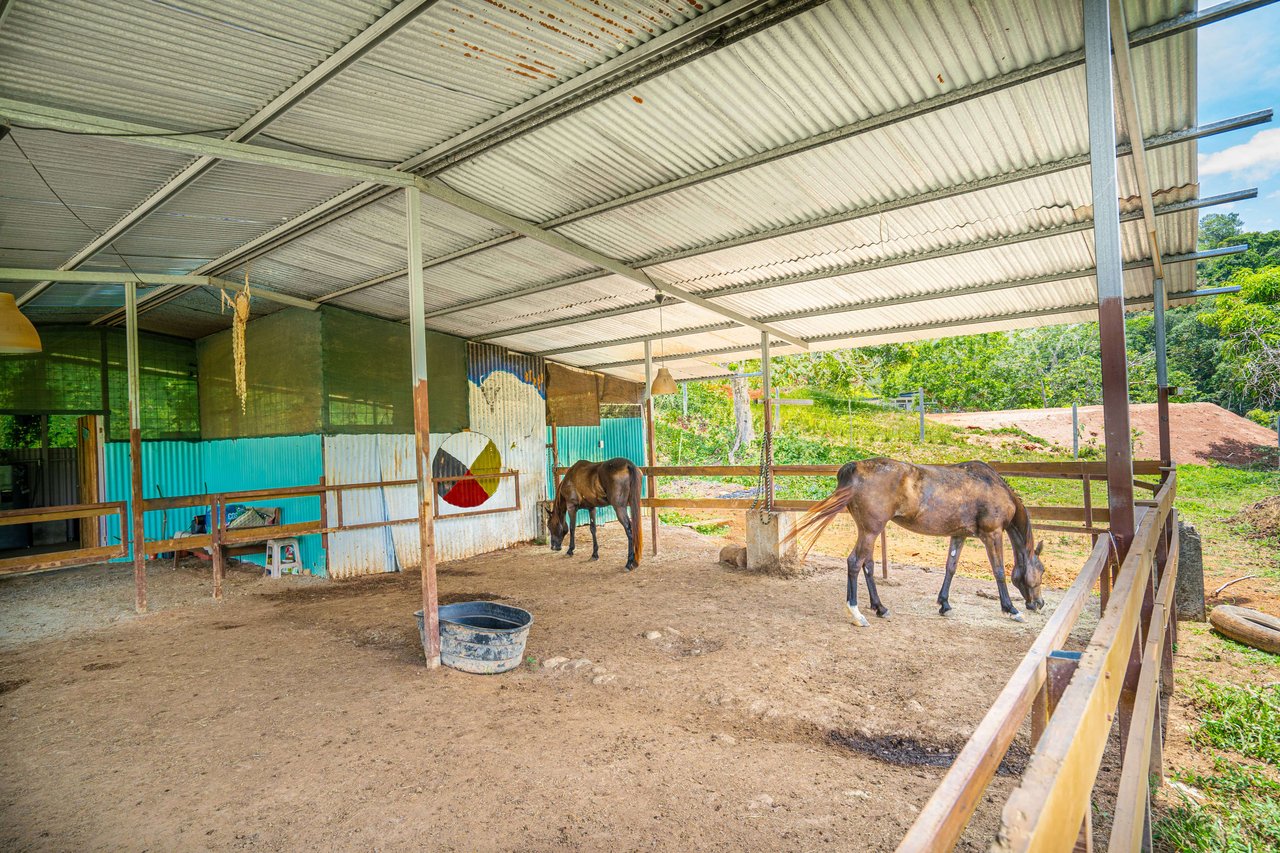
[404,187,440,669]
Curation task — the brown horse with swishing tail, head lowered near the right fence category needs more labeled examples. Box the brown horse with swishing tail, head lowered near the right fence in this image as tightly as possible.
[791,459,1044,628]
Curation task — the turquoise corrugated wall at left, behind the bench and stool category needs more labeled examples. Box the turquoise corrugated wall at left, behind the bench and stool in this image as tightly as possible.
[104,435,325,574]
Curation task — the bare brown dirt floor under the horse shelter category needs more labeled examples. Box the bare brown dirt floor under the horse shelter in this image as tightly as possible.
[0,525,1096,850]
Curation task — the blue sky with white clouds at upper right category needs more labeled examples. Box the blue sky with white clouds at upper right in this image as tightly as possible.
[1198,1,1280,231]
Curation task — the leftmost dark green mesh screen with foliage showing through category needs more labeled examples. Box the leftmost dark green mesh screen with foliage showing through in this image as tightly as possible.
[0,325,200,439]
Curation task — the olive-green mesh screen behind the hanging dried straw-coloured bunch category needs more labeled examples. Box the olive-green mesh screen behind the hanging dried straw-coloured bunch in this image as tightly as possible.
[196,309,323,438]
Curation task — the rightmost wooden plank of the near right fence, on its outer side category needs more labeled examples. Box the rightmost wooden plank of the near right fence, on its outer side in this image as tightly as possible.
[1108,525,1178,850]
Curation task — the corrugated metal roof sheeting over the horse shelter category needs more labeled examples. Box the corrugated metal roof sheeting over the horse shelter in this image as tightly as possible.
[0,0,1218,375]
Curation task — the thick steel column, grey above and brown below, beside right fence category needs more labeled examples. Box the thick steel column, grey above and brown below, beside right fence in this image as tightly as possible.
[1084,0,1134,561]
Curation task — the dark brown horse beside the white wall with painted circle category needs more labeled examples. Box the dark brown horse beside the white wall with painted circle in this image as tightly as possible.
[547,457,643,571]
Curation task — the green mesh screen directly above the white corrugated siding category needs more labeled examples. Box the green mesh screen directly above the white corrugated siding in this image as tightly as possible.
[324,307,470,433]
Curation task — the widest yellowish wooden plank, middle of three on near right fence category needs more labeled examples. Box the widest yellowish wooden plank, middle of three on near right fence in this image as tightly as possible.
[996,476,1176,852]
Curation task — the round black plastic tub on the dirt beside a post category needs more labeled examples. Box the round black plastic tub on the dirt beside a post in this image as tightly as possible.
[413,601,534,675]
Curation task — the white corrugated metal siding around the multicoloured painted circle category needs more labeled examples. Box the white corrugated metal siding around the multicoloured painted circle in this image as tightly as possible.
[324,345,547,578]
